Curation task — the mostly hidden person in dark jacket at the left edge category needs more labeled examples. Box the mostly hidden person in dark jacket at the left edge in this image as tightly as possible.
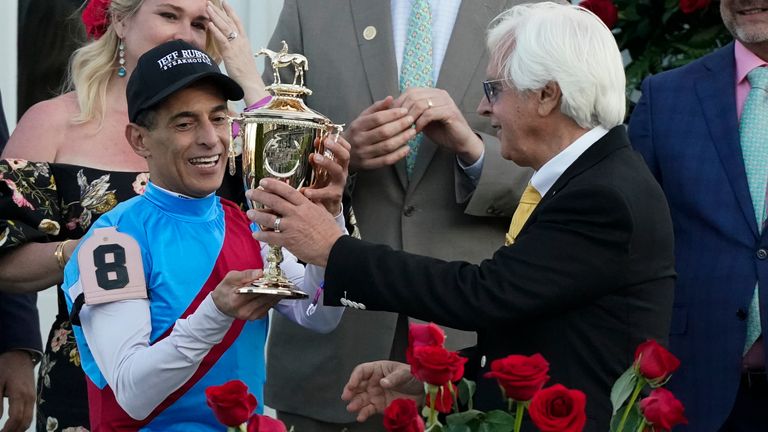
[0,92,43,432]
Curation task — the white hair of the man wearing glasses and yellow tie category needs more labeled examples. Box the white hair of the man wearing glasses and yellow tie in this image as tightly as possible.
[488,2,626,129]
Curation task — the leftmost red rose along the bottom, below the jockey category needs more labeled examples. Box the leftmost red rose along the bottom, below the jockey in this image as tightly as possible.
[205,380,257,427]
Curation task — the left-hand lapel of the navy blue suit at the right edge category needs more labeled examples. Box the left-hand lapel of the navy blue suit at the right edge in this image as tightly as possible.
[695,44,758,236]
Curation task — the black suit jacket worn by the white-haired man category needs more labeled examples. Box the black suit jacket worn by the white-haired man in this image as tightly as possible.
[325,126,675,431]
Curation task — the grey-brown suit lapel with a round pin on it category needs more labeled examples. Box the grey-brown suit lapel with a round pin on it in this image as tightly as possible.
[349,0,408,189]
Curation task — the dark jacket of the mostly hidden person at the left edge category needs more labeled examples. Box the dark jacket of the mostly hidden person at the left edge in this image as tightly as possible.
[0,90,43,354]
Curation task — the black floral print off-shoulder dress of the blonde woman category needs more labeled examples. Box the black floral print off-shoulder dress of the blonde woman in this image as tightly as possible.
[0,159,149,432]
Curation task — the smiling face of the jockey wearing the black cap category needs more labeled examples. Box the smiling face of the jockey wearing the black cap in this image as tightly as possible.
[127,82,229,198]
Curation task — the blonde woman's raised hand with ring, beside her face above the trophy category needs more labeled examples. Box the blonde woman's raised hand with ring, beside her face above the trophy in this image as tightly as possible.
[207,1,269,105]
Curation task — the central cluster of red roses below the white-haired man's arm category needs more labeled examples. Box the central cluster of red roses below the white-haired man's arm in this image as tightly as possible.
[384,324,586,432]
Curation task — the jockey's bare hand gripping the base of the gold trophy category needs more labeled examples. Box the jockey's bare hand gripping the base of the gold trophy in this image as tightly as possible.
[211,270,280,320]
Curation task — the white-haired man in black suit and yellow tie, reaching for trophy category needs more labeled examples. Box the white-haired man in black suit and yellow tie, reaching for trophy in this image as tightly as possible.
[248,3,674,431]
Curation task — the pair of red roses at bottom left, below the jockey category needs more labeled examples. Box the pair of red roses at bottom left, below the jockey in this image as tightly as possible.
[205,380,286,432]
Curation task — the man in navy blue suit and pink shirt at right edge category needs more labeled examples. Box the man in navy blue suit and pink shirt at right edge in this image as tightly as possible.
[629,0,768,432]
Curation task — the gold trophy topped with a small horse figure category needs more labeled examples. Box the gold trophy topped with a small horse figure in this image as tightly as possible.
[229,41,342,299]
